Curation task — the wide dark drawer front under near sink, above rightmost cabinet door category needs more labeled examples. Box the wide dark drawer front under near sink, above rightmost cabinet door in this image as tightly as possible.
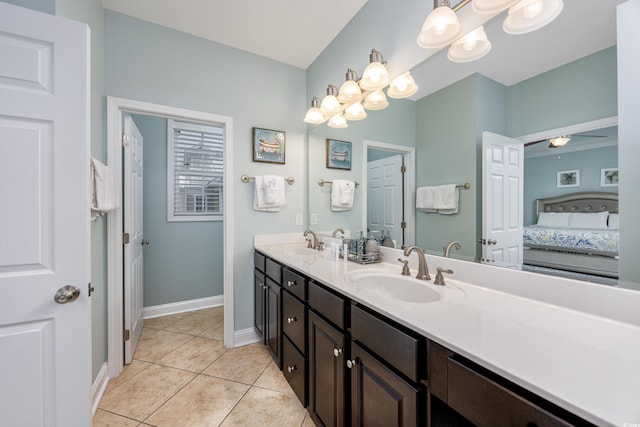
[351,305,426,382]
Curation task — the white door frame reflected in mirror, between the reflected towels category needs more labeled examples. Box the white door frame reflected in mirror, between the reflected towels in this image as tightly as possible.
[362,139,416,246]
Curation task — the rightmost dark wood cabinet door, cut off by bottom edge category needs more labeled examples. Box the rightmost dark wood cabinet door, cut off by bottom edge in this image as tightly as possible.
[349,343,425,427]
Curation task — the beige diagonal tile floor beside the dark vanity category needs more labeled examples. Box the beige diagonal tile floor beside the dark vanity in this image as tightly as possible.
[93,307,314,427]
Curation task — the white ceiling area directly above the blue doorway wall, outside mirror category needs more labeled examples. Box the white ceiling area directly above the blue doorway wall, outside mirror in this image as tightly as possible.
[102,0,367,69]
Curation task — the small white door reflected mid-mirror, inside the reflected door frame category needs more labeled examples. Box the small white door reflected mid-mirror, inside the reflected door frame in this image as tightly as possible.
[367,154,404,246]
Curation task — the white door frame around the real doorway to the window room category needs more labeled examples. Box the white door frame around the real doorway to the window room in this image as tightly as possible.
[107,96,234,378]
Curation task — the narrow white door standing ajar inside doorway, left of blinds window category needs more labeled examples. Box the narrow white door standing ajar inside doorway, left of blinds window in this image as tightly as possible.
[123,114,145,364]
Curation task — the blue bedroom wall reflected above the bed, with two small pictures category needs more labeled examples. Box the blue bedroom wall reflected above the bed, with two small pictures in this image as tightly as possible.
[524,146,618,225]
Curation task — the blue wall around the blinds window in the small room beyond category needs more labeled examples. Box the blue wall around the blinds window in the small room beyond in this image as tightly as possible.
[133,115,224,307]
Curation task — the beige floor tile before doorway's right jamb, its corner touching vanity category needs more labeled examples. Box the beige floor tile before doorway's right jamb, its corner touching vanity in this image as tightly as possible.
[203,346,271,384]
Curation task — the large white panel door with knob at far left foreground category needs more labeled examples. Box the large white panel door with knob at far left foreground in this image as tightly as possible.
[0,2,91,427]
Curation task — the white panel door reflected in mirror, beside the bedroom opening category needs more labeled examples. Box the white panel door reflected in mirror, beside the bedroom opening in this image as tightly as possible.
[482,132,524,268]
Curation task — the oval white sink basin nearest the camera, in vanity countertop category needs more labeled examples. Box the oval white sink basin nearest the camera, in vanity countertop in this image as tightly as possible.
[347,271,463,304]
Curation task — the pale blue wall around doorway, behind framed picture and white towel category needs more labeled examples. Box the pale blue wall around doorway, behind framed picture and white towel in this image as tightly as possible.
[105,11,306,330]
